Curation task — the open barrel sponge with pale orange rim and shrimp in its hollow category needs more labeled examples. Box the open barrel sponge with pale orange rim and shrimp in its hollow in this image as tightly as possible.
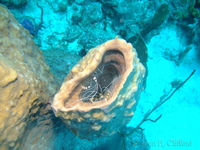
[52,37,145,140]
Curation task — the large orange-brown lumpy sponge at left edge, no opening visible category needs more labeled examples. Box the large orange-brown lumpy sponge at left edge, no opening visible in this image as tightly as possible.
[0,4,56,150]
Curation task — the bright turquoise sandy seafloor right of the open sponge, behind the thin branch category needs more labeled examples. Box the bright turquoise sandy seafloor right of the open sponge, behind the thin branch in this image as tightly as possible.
[128,25,200,150]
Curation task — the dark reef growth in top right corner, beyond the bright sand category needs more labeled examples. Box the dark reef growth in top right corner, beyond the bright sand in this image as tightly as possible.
[171,0,200,59]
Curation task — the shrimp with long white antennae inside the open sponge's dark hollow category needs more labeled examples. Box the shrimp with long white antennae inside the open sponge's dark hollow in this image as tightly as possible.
[64,61,122,107]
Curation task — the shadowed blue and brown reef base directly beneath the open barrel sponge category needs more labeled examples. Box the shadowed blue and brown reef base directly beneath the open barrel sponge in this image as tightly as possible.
[19,114,149,150]
